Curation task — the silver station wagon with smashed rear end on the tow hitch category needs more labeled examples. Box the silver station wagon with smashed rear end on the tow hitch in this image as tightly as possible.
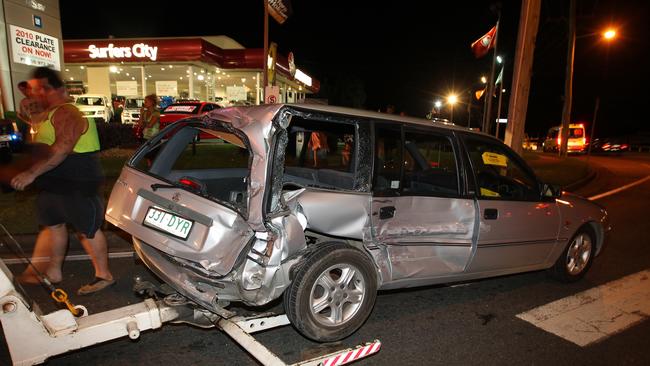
[106,105,609,341]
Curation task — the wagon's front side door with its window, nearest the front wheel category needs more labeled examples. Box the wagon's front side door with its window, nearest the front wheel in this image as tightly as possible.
[463,135,560,273]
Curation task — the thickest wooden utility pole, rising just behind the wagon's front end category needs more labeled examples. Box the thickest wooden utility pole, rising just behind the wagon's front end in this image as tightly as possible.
[505,0,541,154]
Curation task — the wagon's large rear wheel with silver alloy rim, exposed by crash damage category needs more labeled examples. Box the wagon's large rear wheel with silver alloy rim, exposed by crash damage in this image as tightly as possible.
[284,242,377,342]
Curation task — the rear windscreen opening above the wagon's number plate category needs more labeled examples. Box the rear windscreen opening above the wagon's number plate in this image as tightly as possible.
[131,125,251,214]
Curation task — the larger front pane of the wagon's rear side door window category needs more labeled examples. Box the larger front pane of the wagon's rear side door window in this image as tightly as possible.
[402,128,458,197]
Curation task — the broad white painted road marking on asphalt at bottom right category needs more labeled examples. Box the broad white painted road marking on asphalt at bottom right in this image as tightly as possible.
[517,270,650,347]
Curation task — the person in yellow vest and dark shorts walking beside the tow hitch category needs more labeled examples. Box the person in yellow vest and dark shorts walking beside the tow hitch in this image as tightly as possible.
[11,67,115,295]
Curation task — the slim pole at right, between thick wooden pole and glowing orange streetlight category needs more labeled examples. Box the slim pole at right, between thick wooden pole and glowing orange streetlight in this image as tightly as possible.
[559,0,576,156]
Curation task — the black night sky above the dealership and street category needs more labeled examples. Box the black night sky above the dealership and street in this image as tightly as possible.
[60,0,650,136]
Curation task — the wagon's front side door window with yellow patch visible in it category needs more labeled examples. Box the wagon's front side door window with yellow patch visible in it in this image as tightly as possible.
[465,138,540,201]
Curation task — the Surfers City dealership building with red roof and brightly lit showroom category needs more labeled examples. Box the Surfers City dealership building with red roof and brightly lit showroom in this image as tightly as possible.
[61,36,319,104]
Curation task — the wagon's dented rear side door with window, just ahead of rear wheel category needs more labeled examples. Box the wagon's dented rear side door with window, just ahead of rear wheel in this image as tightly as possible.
[371,123,475,284]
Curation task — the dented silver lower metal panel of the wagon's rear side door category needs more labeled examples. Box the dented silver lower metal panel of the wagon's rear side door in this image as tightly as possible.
[372,196,476,288]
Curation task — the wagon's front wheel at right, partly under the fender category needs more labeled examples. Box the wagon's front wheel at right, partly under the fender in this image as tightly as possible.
[550,226,596,283]
